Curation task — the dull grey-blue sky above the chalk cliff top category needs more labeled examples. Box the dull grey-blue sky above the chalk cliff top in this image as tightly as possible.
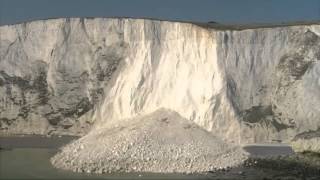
[0,0,320,25]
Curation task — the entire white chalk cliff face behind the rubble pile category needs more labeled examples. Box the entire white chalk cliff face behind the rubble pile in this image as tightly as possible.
[0,18,320,146]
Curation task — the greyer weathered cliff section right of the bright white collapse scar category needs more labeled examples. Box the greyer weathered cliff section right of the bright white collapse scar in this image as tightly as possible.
[217,25,320,142]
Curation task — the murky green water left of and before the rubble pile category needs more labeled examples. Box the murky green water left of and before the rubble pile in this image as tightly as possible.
[0,148,206,179]
